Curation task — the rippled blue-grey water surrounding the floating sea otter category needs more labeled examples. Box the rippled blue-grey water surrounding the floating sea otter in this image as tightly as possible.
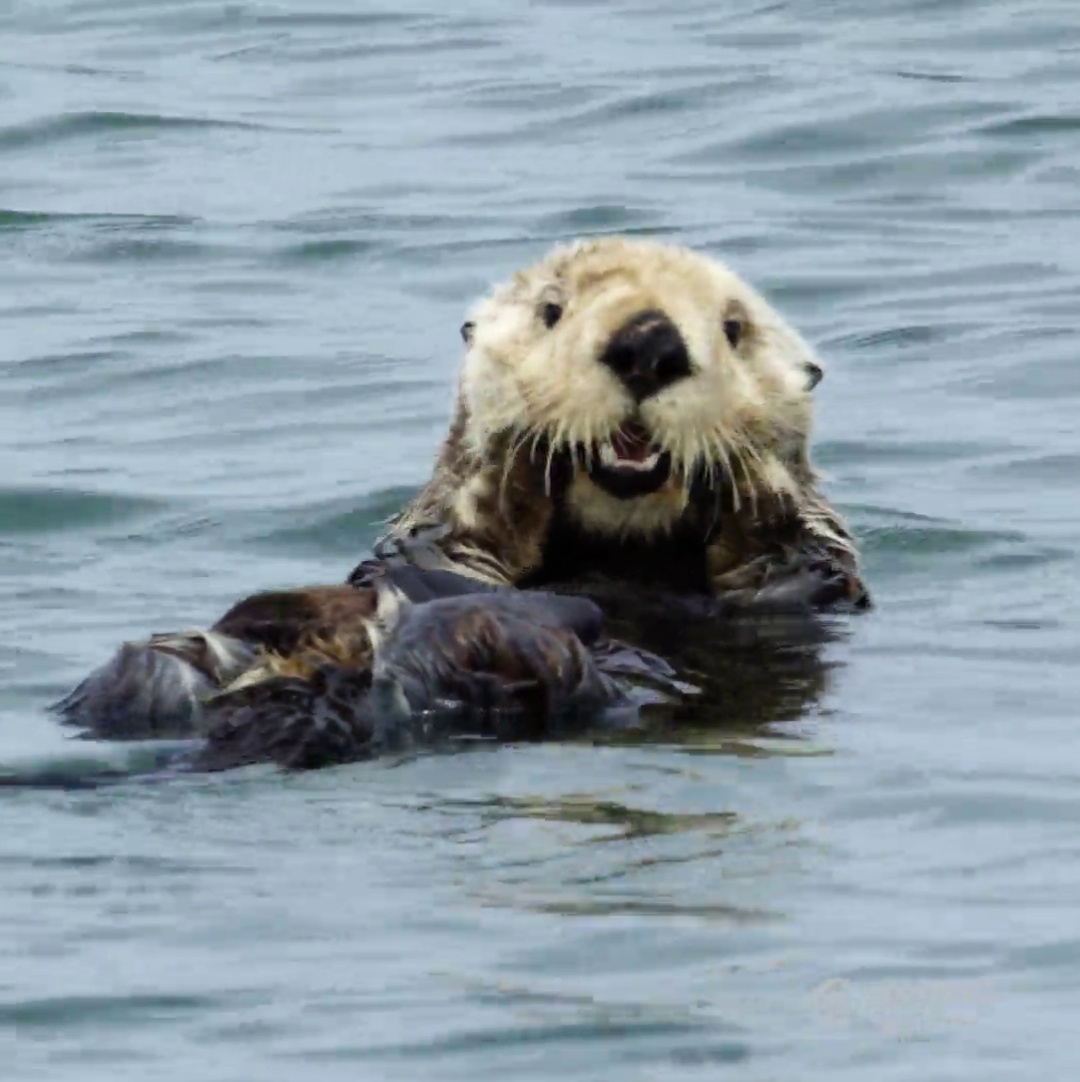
[0,0,1080,1082]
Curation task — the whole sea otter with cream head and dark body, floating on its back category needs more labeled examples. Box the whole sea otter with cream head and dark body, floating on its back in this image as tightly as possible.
[56,237,869,769]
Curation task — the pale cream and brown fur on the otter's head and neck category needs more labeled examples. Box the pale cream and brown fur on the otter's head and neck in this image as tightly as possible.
[391,238,855,597]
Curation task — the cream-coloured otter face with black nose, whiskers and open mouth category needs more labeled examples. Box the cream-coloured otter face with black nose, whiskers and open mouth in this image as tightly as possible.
[462,238,821,533]
